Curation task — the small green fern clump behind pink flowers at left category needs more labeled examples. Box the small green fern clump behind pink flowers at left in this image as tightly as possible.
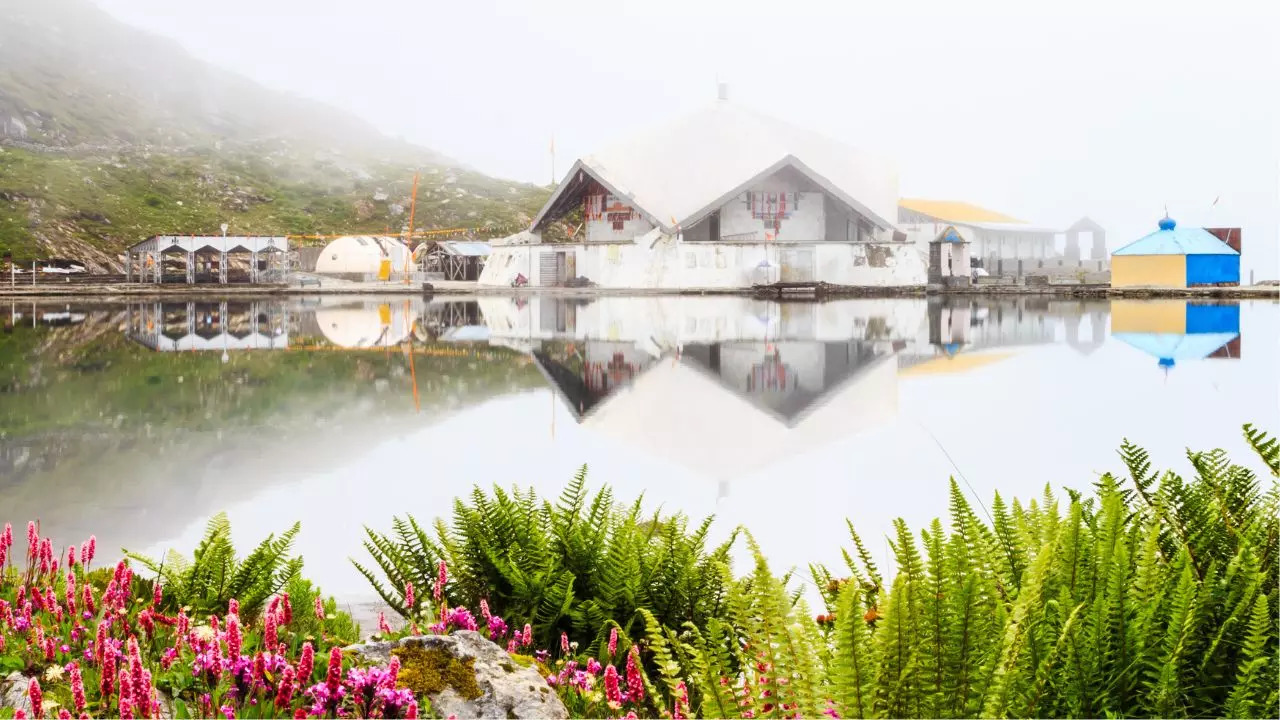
[124,512,302,619]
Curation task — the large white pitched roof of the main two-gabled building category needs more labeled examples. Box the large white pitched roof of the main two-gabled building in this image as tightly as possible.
[534,100,897,231]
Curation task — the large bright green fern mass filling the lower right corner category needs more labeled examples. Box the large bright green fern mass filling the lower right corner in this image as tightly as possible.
[643,425,1280,717]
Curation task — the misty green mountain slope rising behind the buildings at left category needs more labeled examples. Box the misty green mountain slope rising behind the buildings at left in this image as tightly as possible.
[0,0,547,270]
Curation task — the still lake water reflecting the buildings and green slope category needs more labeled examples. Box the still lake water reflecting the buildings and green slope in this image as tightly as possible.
[0,296,1280,598]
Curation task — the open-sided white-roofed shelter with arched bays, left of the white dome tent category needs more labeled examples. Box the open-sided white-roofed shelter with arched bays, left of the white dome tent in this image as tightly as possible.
[124,234,289,284]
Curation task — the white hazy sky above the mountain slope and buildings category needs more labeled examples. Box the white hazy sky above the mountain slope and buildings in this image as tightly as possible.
[96,0,1280,274]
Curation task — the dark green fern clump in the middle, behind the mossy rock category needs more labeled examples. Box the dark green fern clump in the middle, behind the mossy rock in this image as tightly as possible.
[356,468,733,656]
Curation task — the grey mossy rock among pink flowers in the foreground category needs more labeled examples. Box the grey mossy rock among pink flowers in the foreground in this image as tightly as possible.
[346,630,568,720]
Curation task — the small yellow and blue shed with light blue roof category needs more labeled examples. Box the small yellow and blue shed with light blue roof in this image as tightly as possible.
[1111,218,1240,287]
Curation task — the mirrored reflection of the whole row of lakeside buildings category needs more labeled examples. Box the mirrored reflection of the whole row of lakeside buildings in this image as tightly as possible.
[117,296,1240,495]
